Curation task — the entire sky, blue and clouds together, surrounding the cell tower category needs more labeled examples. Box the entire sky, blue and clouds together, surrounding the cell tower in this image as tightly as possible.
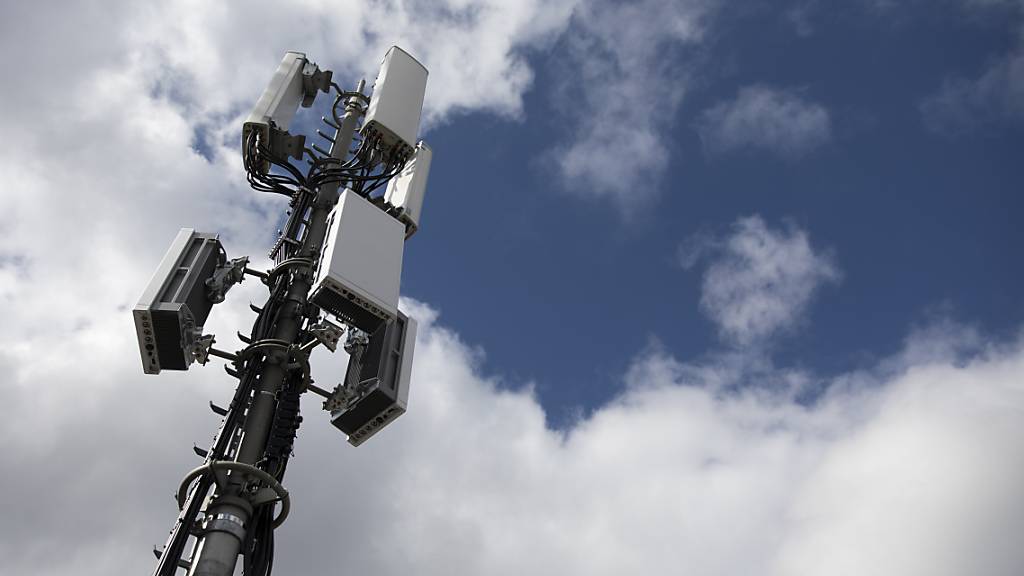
[0,0,1024,576]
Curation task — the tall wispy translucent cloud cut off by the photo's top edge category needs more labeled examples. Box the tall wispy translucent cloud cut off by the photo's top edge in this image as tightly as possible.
[548,0,719,209]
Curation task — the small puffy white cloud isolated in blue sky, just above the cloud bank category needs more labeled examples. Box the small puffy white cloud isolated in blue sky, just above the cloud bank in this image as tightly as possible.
[680,216,841,345]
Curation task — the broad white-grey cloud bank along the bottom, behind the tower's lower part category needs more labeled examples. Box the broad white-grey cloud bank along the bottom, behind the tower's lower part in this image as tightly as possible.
[8,295,1024,576]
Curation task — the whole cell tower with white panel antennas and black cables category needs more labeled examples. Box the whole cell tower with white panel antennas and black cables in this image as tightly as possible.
[133,46,431,576]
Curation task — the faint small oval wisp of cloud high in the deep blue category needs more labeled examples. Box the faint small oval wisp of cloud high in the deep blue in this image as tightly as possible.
[696,85,831,159]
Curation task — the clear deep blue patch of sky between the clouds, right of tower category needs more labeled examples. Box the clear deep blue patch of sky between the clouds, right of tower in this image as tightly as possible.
[393,3,1024,421]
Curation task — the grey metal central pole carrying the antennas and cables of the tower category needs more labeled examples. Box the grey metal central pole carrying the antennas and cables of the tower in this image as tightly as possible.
[188,81,364,576]
